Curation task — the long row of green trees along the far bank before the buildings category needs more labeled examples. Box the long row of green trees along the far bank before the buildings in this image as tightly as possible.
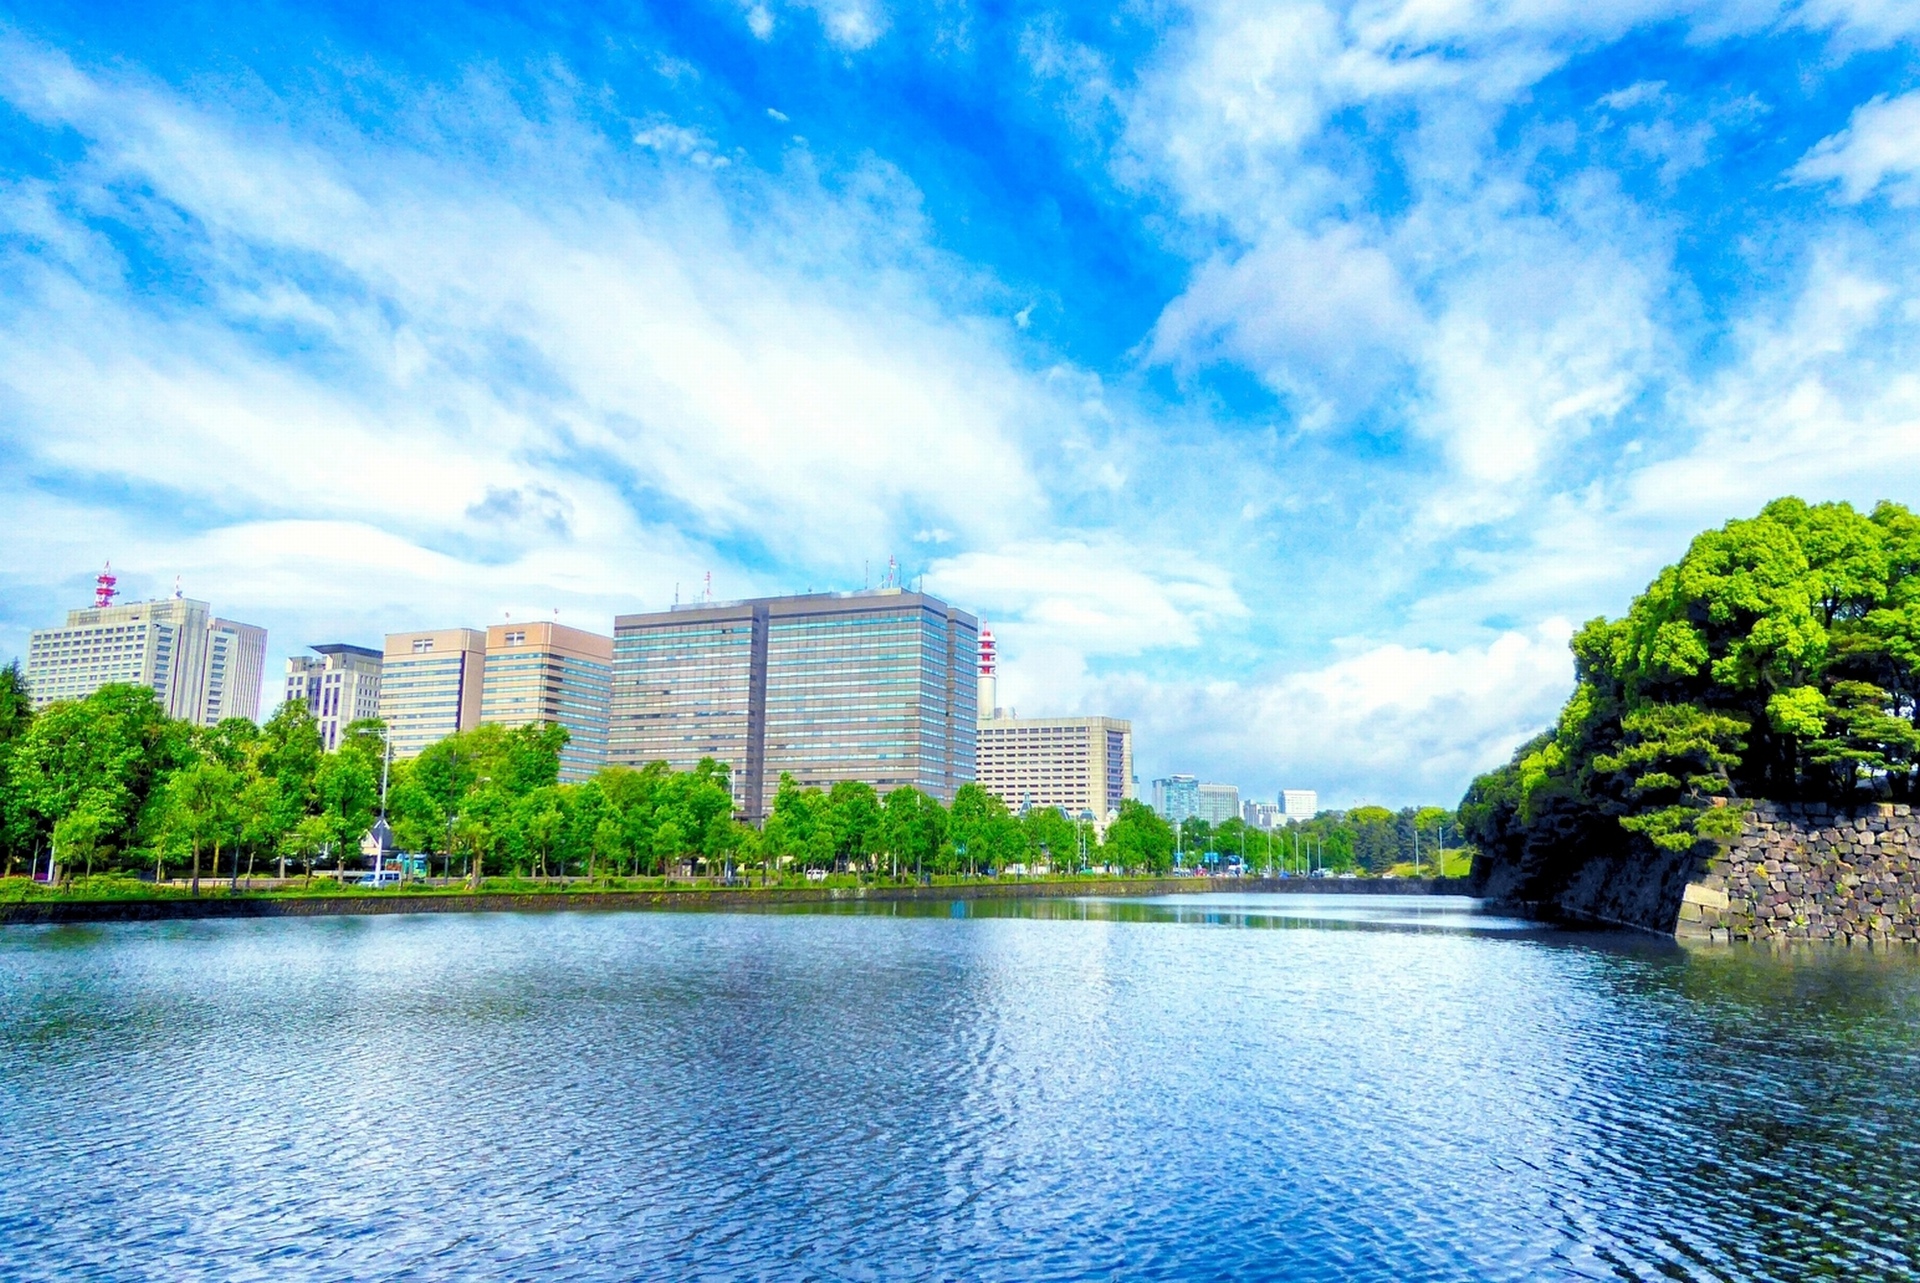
[0,665,1198,884]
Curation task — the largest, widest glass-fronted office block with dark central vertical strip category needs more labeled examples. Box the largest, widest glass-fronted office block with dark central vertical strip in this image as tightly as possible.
[609,588,979,820]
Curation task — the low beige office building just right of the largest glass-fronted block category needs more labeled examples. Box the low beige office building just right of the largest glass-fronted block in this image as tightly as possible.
[975,714,1133,837]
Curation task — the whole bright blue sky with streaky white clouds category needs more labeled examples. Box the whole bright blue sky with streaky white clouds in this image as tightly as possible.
[0,0,1920,805]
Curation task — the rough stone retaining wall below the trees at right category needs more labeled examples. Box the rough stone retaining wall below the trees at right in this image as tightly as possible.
[1678,803,1920,945]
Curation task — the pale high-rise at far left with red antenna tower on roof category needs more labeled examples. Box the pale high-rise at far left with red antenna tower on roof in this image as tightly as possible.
[27,570,267,726]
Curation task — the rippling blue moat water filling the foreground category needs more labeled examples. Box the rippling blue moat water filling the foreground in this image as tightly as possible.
[0,895,1920,1279]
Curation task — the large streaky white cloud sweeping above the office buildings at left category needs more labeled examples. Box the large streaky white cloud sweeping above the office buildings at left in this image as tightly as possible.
[0,44,1152,710]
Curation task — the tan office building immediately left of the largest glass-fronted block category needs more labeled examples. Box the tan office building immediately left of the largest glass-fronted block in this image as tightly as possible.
[480,624,612,784]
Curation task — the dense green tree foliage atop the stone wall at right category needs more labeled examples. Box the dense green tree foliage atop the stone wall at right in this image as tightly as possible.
[1461,497,1920,876]
